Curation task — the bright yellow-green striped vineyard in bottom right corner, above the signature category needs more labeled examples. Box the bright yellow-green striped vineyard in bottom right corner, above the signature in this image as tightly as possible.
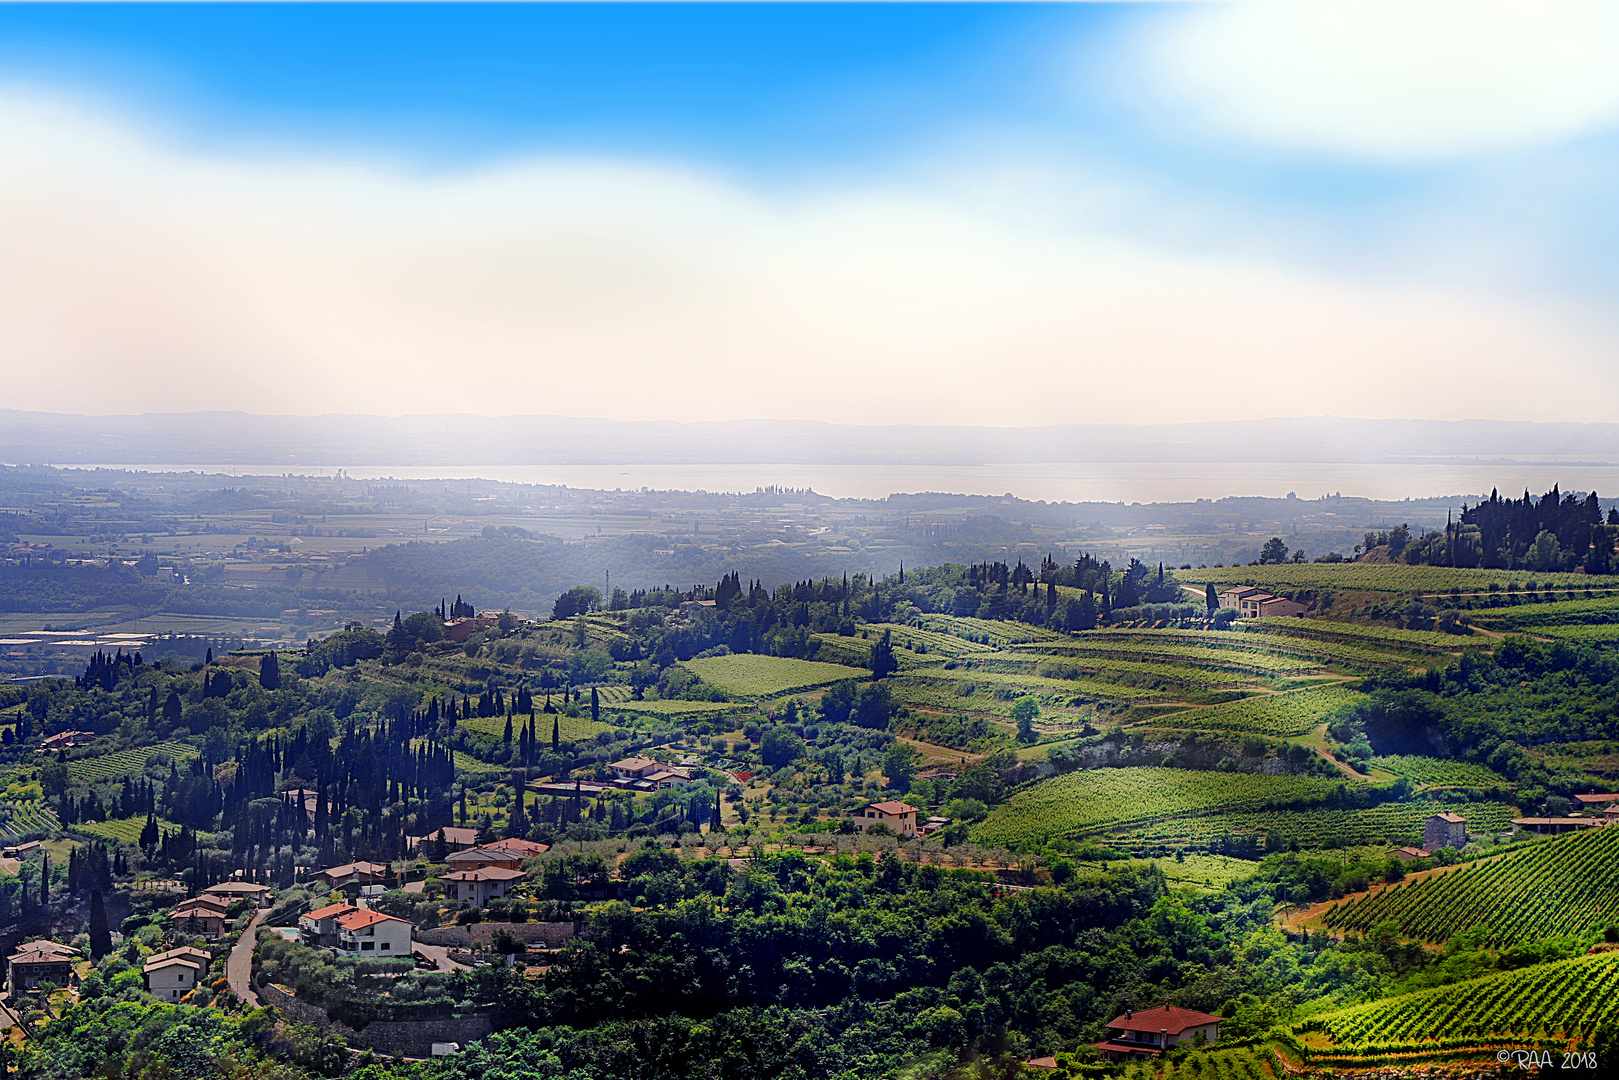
[1294,952,1619,1057]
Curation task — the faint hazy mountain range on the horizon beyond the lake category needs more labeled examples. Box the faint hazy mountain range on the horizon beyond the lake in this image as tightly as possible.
[0,410,1619,466]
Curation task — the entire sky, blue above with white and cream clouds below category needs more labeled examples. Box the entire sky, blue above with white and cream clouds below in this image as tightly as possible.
[0,0,1619,424]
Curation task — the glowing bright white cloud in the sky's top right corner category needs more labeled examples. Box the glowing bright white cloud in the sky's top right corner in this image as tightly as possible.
[1125,0,1619,160]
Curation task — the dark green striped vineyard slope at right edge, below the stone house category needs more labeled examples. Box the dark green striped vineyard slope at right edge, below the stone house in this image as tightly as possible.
[1323,823,1619,946]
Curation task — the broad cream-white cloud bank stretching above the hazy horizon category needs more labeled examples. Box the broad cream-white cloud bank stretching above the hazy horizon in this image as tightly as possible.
[0,92,1619,424]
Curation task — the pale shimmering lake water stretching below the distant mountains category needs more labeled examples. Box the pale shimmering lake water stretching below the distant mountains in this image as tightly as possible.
[58,458,1619,502]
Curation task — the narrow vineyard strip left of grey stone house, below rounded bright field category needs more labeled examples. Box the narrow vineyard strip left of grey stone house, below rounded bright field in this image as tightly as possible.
[1107,798,1517,852]
